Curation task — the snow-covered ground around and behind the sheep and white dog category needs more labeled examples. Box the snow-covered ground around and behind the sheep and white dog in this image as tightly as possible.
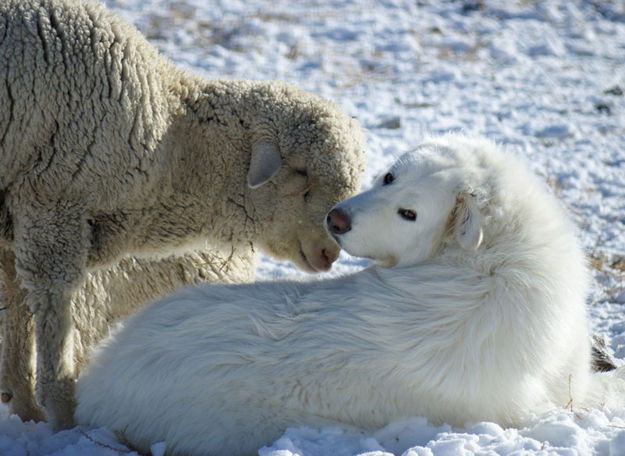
[0,0,625,456]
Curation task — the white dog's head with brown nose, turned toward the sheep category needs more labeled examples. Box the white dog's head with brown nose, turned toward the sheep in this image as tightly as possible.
[326,134,483,267]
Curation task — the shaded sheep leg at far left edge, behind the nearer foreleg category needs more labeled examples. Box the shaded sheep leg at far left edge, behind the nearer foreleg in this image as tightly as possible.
[0,249,43,421]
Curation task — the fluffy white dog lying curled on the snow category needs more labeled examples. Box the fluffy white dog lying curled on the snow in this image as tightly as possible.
[76,135,616,456]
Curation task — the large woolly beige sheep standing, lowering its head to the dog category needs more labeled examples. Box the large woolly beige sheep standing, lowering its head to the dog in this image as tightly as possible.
[0,0,364,429]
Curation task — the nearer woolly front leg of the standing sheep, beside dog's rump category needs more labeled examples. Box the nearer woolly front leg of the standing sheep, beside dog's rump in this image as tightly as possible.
[14,201,90,429]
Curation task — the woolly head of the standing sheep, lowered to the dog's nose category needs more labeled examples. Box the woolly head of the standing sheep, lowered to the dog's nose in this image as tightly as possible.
[247,89,365,272]
